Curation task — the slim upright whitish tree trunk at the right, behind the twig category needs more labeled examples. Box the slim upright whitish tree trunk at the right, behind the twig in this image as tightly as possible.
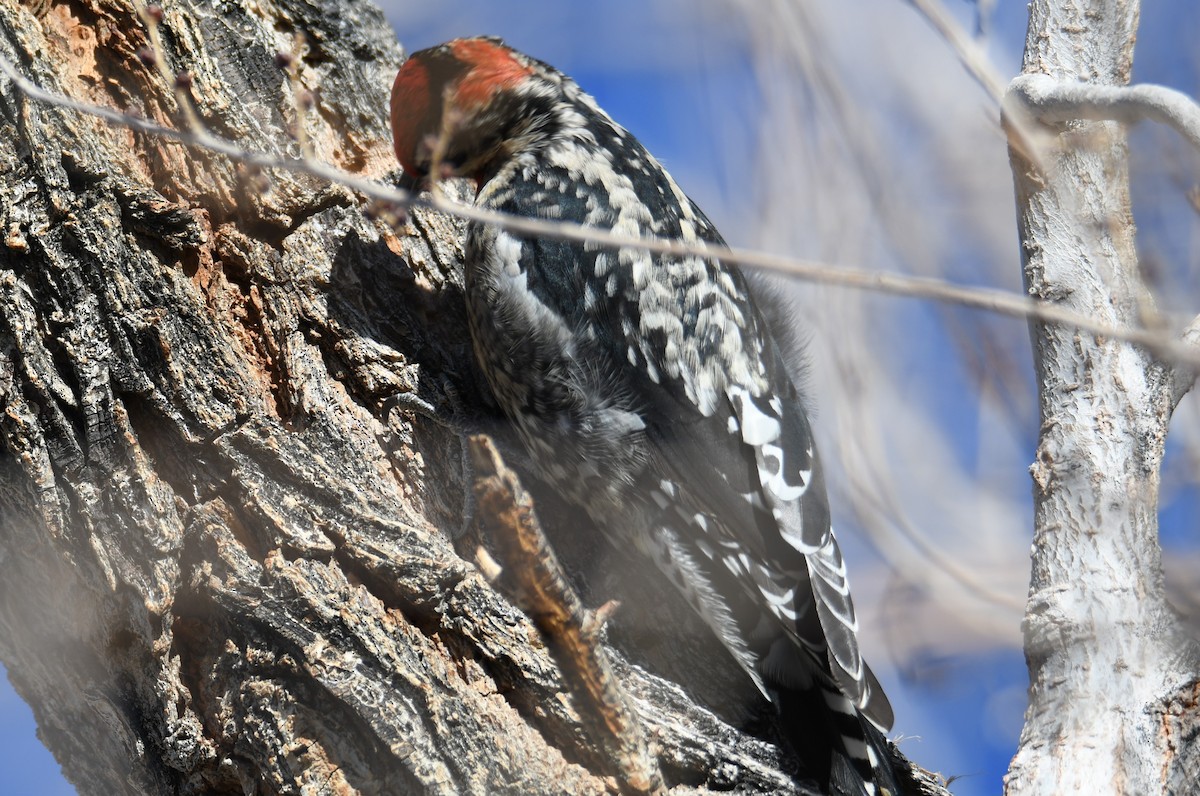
[1006,0,1200,796]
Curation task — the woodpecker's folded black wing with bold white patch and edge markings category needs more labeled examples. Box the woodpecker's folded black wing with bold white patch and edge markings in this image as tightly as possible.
[648,300,892,728]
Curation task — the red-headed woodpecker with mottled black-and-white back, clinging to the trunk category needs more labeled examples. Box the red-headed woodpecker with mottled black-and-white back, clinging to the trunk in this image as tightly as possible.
[391,37,898,795]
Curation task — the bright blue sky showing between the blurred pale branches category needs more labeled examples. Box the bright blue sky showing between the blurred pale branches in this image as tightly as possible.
[0,0,1200,796]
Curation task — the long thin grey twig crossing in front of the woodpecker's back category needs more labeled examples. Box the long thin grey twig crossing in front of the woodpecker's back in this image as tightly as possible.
[0,51,1200,367]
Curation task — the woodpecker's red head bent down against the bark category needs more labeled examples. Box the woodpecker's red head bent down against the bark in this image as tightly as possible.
[391,37,552,181]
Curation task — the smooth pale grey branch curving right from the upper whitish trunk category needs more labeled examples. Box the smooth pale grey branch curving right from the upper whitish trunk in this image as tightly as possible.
[1009,74,1200,150]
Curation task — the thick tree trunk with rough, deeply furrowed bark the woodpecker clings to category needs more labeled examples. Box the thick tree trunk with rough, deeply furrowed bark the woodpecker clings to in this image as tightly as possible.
[0,0,935,794]
